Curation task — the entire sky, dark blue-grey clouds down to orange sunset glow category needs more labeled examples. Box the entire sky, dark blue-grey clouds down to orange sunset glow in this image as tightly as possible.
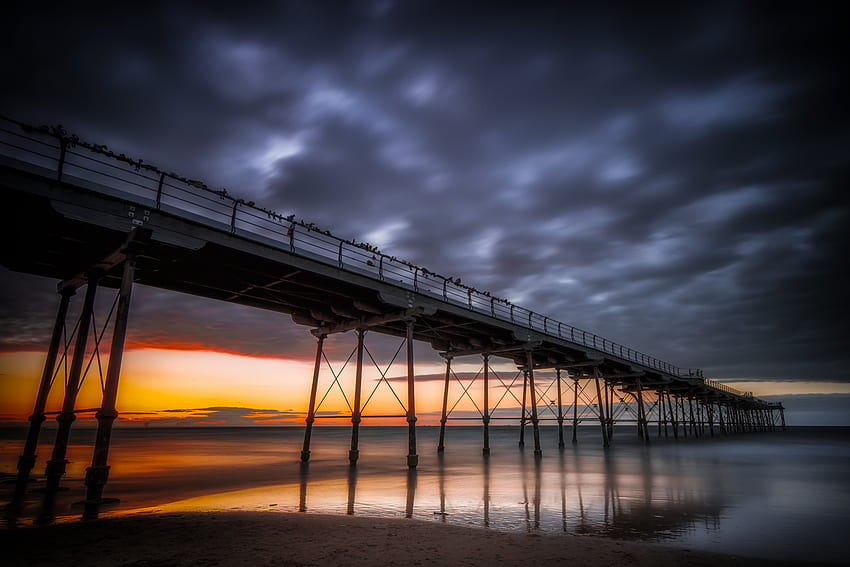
[0,0,850,425]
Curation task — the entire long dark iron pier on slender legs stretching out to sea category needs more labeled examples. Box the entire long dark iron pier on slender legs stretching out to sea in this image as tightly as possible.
[0,119,784,515]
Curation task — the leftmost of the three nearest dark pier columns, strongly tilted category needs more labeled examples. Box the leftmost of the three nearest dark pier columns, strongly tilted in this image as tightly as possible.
[12,287,74,508]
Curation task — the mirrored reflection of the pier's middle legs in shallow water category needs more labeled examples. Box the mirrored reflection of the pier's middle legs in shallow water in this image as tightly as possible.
[297,445,722,540]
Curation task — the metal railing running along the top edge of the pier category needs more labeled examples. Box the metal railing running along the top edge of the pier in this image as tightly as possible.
[0,117,745,396]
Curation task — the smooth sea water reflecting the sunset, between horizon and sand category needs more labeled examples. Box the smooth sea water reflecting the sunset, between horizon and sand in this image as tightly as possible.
[0,427,850,562]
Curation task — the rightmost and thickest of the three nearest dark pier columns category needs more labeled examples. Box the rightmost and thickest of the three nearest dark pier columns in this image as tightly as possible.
[86,256,136,506]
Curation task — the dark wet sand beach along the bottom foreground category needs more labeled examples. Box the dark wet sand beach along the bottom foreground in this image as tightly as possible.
[0,512,816,567]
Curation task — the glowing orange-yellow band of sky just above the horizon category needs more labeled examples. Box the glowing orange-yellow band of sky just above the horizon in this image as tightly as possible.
[0,349,850,425]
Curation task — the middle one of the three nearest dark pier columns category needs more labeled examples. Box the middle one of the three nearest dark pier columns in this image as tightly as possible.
[44,276,97,494]
